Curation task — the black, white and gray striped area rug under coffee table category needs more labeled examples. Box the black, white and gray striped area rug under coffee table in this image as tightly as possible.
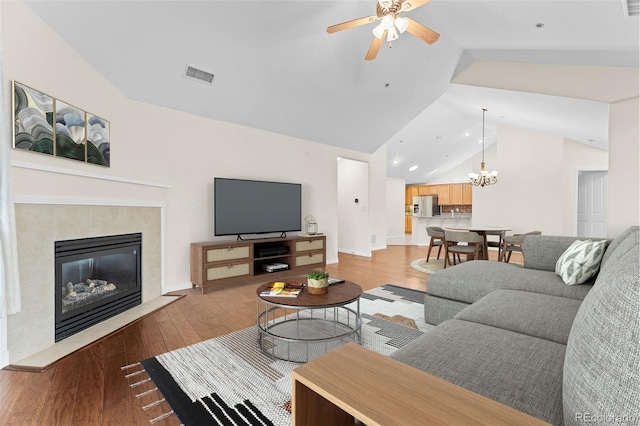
[141,284,432,426]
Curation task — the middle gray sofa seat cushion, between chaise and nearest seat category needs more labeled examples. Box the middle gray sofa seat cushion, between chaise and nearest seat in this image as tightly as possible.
[454,290,582,345]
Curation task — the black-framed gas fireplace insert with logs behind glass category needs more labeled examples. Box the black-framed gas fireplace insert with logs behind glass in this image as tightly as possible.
[55,233,142,342]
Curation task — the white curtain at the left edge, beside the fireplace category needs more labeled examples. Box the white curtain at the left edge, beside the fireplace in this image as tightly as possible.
[0,30,20,318]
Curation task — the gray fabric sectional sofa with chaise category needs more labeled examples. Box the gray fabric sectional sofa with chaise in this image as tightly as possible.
[392,226,640,425]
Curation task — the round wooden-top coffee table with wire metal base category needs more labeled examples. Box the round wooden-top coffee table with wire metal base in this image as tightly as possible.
[256,277,362,362]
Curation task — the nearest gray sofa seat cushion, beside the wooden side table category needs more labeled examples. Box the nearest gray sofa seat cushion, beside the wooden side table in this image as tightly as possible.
[391,319,565,424]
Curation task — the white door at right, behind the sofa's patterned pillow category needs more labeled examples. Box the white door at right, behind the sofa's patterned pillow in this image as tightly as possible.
[577,170,609,238]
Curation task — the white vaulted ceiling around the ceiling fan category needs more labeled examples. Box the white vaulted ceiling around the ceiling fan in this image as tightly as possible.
[27,0,639,183]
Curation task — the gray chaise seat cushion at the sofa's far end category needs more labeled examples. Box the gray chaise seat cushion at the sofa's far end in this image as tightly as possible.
[427,260,593,303]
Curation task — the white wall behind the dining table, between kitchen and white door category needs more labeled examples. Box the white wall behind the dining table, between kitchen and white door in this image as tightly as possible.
[473,125,608,235]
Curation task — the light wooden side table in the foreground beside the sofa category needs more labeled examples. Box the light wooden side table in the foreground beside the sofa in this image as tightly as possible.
[291,343,547,426]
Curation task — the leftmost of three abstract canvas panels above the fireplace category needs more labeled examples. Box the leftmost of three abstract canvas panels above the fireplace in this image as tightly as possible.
[13,81,54,155]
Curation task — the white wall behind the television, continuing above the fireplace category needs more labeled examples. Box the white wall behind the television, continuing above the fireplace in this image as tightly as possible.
[0,2,386,292]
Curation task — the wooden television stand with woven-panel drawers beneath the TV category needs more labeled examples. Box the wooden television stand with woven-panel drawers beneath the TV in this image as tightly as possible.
[191,235,327,294]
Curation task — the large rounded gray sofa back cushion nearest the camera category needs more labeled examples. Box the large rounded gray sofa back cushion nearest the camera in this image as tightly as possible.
[563,228,640,425]
